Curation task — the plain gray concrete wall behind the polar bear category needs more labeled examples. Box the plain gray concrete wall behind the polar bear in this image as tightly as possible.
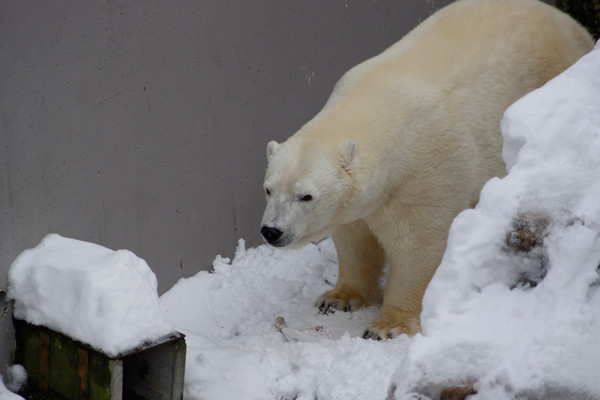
[0,0,450,374]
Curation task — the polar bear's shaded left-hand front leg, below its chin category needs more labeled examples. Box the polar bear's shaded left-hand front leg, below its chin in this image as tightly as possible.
[316,220,385,314]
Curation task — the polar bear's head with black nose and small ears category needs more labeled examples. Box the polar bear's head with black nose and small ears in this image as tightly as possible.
[261,138,356,247]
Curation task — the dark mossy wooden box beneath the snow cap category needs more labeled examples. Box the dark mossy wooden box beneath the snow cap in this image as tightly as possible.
[14,319,186,400]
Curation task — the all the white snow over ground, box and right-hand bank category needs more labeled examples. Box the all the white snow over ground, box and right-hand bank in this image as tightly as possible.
[0,39,600,400]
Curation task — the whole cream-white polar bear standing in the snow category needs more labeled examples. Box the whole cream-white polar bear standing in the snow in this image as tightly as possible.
[261,0,594,339]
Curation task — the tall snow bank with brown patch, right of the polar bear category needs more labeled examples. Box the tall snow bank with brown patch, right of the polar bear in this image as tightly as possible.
[394,44,600,400]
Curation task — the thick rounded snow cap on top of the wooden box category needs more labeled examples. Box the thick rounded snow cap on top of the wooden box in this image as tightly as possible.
[8,234,173,356]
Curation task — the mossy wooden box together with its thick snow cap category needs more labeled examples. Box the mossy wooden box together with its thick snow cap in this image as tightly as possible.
[9,234,185,400]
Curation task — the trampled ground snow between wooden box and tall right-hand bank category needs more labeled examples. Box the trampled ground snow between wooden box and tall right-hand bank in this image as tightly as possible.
[160,240,410,400]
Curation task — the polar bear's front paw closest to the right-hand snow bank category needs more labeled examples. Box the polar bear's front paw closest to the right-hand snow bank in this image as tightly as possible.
[363,309,421,340]
